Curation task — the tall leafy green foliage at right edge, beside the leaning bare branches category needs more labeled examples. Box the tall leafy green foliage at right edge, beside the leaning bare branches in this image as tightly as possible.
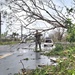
[65,18,75,42]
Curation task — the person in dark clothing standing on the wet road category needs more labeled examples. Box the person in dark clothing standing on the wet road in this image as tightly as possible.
[35,30,42,51]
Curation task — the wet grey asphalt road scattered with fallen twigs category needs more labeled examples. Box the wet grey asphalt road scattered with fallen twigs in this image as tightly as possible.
[0,43,52,75]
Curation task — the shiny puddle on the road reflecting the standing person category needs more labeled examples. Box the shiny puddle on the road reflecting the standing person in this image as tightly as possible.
[17,49,56,69]
